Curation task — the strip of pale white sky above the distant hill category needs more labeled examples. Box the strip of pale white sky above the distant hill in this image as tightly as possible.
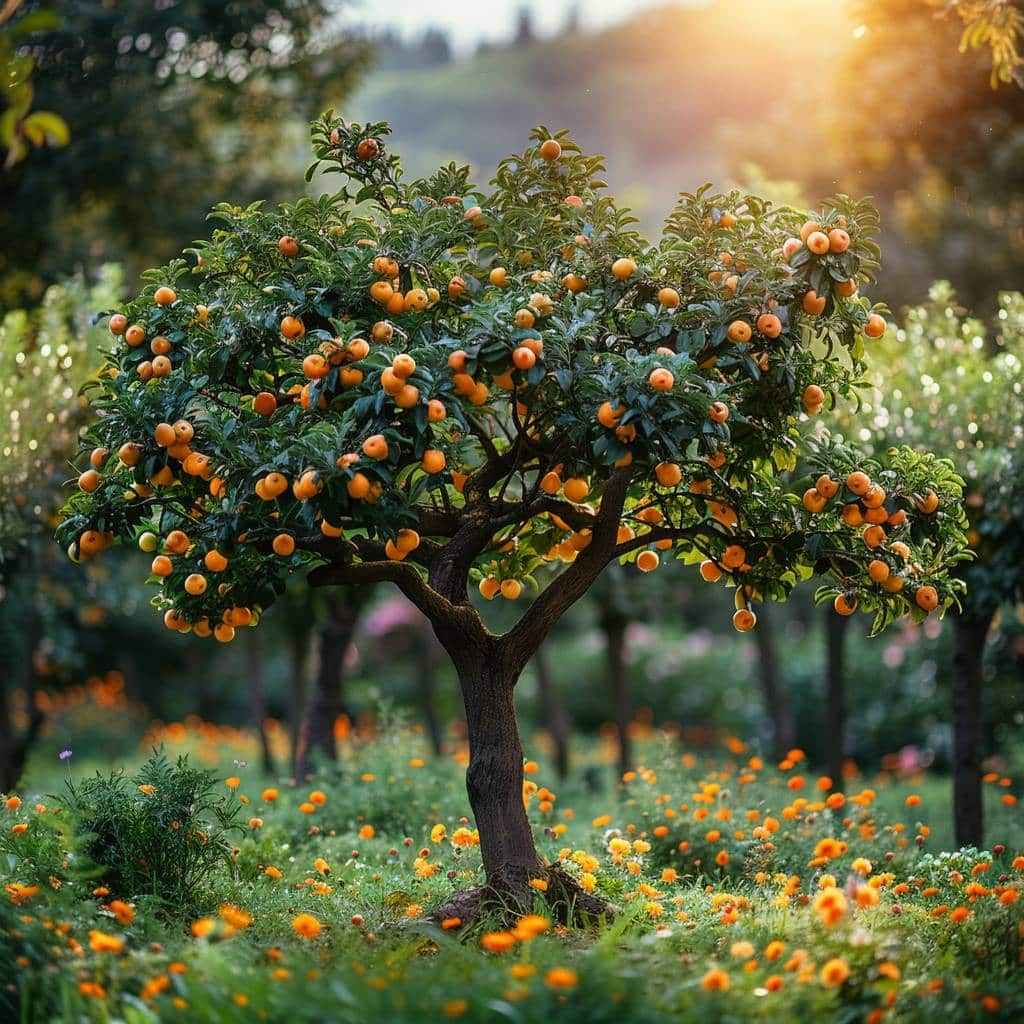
[345,0,692,53]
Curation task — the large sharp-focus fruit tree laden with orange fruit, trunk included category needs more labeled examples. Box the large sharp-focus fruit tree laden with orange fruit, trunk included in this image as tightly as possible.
[58,115,966,920]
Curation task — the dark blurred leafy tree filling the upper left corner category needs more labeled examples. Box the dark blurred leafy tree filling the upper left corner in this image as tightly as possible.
[0,0,367,304]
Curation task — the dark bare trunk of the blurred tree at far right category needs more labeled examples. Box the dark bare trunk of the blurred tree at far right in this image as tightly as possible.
[952,612,992,849]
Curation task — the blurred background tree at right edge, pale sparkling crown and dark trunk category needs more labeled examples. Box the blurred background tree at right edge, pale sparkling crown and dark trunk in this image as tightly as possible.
[848,283,1024,846]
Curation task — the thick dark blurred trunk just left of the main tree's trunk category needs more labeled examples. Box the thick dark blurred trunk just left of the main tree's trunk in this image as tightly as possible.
[295,587,370,778]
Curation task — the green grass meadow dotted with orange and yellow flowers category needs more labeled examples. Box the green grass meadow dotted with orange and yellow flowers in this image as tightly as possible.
[0,726,1024,1022]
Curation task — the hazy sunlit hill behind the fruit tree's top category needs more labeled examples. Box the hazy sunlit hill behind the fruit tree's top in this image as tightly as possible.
[341,0,853,230]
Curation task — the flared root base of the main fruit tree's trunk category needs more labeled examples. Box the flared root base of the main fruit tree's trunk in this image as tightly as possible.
[429,864,617,928]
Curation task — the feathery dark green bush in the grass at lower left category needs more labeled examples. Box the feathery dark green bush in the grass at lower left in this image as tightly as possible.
[66,752,241,913]
